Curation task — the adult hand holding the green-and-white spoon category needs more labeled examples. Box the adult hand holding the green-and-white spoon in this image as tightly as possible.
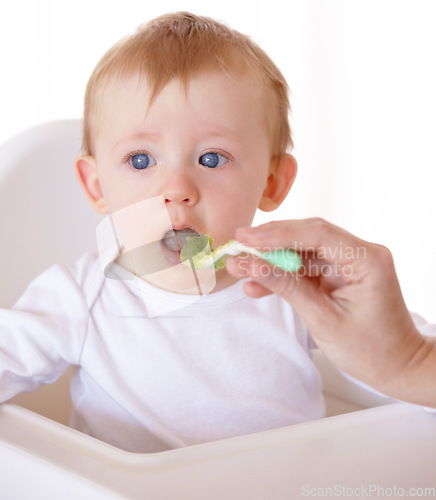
[227,219,436,407]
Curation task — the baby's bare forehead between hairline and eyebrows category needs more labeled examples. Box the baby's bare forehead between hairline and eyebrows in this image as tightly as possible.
[89,68,274,156]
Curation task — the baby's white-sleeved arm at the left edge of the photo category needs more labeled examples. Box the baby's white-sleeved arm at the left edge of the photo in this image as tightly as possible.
[0,266,88,402]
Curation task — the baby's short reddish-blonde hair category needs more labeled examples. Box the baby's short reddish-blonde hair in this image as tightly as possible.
[83,12,293,155]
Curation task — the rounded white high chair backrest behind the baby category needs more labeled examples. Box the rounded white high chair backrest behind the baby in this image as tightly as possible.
[0,120,100,307]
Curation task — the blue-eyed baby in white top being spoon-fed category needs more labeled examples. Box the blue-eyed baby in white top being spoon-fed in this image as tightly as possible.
[0,13,324,452]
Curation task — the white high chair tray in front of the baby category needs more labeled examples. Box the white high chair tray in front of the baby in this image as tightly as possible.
[0,403,436,500]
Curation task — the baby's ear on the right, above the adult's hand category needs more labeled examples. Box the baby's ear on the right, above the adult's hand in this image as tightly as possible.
[259,154,297,212]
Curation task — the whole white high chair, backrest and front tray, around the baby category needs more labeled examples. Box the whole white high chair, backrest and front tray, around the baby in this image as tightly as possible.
[0,120,436,500]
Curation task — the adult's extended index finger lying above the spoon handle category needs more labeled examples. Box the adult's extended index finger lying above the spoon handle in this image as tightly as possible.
[236,219,370,265]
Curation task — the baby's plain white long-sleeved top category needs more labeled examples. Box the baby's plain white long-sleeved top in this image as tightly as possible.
[0,254,324,452]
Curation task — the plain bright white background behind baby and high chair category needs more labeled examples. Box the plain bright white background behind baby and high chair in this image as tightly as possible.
[0,0,436,322]
